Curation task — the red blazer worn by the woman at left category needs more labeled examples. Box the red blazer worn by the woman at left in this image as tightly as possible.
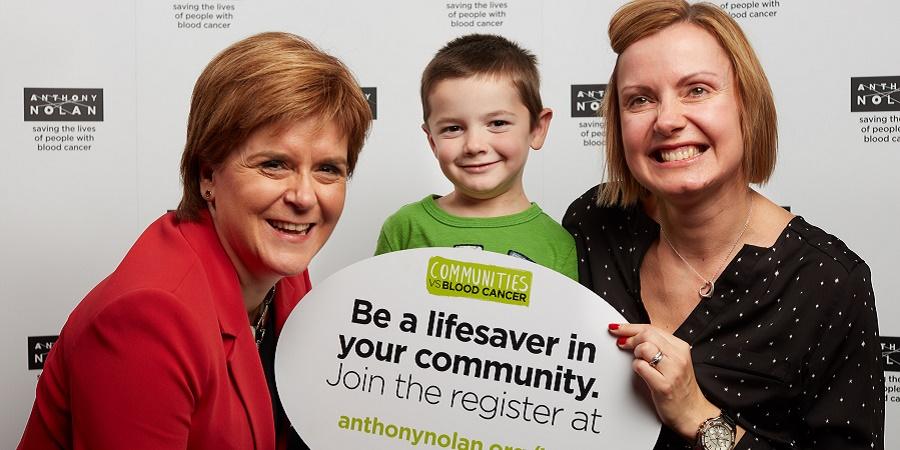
[18,213,310,450]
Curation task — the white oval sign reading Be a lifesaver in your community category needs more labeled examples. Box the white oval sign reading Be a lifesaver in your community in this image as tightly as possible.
[275,248,660,450]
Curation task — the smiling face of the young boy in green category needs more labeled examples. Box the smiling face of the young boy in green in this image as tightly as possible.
[423,76,552,206]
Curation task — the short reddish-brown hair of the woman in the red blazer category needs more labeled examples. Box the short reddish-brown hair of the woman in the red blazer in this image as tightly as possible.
[176,32,372,220]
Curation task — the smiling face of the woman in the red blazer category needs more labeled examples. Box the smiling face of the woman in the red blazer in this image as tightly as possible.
[200,119,348,293]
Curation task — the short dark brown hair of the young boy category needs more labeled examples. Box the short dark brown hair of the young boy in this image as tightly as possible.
[420,34,544,127]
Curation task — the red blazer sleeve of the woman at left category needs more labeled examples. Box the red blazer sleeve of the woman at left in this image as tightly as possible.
[20,289,217,450]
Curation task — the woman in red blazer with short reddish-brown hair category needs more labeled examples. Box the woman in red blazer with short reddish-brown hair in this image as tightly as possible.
[19,33,371,450]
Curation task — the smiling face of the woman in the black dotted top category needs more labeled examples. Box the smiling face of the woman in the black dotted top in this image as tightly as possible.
[617,23,747,202]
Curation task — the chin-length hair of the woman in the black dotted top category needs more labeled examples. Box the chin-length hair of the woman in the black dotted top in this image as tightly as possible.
[599,0,778,206]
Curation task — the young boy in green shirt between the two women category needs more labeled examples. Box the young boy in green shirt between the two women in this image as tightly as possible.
[375,34,578,280]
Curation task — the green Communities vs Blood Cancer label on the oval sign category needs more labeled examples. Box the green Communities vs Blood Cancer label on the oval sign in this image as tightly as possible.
[425,256,533,307]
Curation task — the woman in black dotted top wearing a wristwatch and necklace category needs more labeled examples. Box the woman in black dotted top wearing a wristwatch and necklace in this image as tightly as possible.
[563,0,884,450]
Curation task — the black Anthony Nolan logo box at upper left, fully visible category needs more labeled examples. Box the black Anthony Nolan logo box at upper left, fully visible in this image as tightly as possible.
[25,88,103,122]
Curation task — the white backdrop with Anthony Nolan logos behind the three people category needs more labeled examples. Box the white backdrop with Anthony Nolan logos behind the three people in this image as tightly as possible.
[0,0,900,448]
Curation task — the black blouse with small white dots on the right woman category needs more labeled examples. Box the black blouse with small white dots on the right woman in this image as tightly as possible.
[563,187,884,450]
